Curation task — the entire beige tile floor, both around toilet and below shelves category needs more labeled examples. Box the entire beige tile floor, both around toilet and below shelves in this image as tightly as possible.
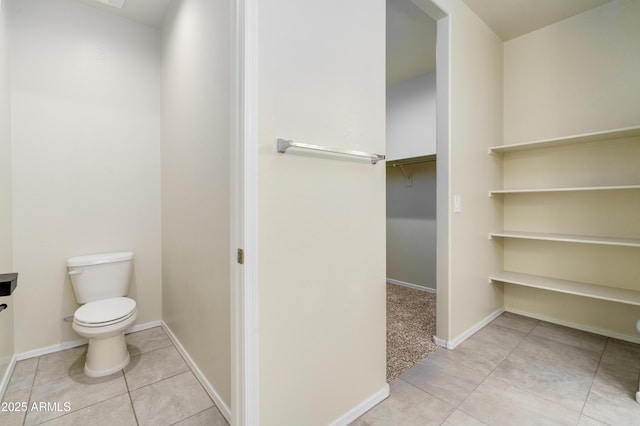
[5,313,640,426]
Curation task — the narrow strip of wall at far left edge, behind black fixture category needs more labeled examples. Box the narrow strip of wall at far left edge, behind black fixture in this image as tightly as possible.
[0,0,14,380]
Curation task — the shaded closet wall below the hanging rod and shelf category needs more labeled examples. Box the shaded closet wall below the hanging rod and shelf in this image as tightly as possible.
[387,161,437,289]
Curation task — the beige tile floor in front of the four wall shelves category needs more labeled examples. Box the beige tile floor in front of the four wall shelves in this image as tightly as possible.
[353,313,640,426]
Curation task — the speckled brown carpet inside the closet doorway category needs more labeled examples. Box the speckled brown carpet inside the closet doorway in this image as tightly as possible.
[387,284,438,382]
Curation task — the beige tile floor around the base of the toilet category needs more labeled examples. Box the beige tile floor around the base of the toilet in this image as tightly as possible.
[0,327,227,426]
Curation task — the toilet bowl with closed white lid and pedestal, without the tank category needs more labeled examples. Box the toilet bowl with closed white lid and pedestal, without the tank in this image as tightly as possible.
[72,297,138,377]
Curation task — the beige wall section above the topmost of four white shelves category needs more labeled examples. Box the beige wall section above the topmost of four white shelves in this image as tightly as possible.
[504,0,640,144]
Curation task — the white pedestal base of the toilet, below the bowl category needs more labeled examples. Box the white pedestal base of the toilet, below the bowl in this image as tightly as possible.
[84,331,131,377]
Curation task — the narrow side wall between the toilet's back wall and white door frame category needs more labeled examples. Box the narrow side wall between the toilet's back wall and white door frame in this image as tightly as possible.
[162,0,231,413]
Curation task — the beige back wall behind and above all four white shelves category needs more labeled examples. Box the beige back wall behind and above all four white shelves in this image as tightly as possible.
[504,1,640,339]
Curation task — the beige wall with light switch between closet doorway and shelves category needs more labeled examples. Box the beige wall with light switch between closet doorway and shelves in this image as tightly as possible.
[437,0,503,341]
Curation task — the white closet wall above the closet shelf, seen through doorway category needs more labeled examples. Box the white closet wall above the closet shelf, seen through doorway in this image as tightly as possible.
[386,70,436,160]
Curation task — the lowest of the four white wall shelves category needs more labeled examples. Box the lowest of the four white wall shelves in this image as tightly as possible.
[489,271,640,306]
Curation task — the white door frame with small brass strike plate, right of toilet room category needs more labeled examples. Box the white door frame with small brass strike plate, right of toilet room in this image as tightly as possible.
[230,0,260,425]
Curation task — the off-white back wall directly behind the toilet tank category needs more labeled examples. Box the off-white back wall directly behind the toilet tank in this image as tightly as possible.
[11,0,162,353]
